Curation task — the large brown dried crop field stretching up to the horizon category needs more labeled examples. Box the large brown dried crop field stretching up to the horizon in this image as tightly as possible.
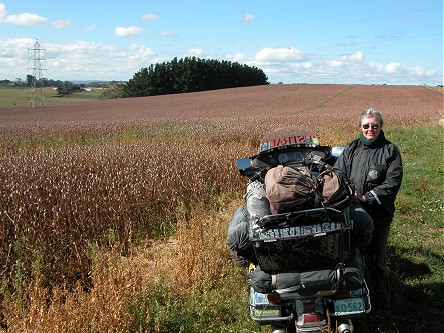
[0,84,444,333]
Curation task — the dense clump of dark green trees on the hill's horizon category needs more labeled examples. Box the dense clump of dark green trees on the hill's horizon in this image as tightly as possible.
[122,57,269,97]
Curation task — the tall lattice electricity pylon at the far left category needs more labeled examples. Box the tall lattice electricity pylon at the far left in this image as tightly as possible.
[28,41,46,107]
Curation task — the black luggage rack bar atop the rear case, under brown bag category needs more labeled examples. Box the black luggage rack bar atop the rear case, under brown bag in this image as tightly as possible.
[256,207,344,228]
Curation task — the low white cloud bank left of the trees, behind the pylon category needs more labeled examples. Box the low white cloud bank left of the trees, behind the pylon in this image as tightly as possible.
[0,37,167,81]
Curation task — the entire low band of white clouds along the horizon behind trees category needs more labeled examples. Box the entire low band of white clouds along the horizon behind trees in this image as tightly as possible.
[0,37,442,85]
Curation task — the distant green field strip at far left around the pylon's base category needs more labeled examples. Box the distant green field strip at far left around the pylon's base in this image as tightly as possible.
[0,87,103,106]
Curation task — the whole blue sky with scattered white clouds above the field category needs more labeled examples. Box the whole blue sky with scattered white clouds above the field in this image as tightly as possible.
[0,0,443,86]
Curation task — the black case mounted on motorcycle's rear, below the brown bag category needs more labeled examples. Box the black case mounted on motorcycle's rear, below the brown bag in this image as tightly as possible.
[249,208,350,272]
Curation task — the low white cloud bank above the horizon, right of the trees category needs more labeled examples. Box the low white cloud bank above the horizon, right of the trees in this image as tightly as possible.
[246,46,440,84]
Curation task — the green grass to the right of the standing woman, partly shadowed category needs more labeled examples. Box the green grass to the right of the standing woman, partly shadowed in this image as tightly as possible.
[382,125,444,332]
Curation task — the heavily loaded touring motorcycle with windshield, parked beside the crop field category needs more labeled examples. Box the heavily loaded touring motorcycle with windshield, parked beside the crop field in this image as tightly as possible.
[232,127,371,333]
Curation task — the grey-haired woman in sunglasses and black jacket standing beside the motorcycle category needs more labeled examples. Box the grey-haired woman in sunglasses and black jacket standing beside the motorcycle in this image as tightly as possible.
[334,108,403,306]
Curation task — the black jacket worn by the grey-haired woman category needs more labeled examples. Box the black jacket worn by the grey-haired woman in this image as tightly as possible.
[334,132,403,224]
